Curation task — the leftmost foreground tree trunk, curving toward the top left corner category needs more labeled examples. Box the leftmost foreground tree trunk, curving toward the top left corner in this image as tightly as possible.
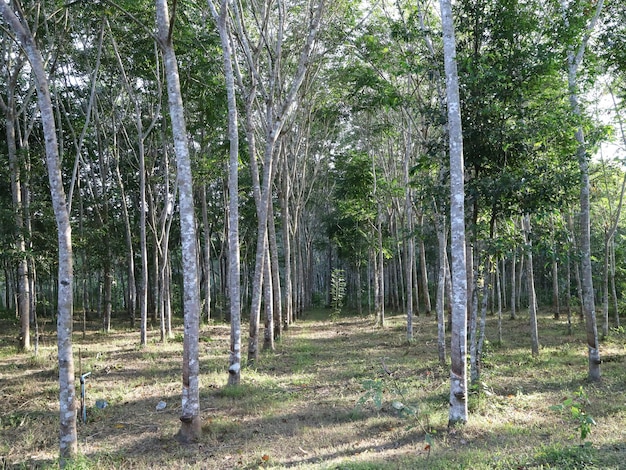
[0,1,78,467]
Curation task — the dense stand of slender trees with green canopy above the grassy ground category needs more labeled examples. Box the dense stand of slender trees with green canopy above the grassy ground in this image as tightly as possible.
[0,0,626,462]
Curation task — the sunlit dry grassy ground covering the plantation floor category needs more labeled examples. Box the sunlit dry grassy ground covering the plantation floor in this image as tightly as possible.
[0,311,626,470]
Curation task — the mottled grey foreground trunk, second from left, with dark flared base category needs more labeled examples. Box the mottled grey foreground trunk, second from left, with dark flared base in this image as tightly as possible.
[156,0,202,442]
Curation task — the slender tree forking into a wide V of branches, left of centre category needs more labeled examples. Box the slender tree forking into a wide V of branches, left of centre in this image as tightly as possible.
[229,0,326,364]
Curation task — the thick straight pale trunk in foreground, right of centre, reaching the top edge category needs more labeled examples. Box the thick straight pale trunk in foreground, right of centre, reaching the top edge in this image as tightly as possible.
[439,0,468,425]
